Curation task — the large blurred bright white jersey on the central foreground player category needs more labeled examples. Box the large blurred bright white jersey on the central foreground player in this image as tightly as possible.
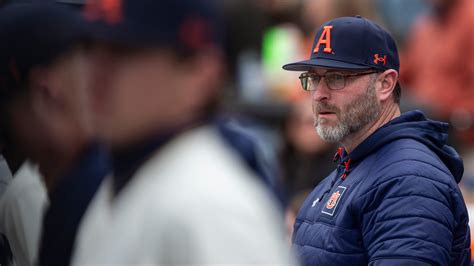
[72,127,294,265]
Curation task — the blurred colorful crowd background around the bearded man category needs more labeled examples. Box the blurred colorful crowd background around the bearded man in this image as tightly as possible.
[0,0,474,254]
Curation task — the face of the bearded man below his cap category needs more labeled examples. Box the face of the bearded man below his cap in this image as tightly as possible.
[311,71,381,142]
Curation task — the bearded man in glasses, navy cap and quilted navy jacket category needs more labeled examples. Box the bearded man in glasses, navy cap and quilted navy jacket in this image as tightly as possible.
[283,16,471,265]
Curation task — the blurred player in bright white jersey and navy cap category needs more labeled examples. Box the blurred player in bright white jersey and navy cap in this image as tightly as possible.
[73,0,293,265]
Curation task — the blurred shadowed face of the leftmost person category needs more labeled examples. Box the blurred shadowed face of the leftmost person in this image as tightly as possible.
[0,49,91,161]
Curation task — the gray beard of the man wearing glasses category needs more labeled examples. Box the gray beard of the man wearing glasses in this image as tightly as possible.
[315,84,381,142]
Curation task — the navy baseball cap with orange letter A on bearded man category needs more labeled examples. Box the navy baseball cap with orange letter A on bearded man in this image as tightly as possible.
[283,16,400,72]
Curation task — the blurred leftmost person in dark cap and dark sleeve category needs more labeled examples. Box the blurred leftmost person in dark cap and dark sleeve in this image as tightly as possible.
[0,3,110,265]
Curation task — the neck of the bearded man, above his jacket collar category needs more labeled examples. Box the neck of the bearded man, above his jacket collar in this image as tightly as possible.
[341,102,400,153]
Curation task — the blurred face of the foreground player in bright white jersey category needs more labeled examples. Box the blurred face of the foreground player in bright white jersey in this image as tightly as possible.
[88,45,205,149]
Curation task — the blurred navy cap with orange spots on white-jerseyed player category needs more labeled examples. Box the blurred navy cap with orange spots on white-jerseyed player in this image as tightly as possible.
[83,0,223,51]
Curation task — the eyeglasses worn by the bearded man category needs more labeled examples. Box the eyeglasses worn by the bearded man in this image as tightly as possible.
[300,71,377,91]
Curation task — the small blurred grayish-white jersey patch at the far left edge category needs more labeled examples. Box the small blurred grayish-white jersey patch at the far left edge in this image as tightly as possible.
[0,162,48,266]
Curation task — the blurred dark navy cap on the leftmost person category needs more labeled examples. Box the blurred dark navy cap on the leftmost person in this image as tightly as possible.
[0,1,89,101]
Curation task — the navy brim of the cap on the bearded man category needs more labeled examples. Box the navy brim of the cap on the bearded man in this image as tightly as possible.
[283,58,371,71]
